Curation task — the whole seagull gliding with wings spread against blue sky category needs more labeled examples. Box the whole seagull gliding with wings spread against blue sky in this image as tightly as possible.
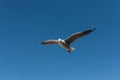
[41,28,96,53]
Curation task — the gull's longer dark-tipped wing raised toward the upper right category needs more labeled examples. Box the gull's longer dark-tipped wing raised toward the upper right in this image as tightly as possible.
[65,28,96,44]
